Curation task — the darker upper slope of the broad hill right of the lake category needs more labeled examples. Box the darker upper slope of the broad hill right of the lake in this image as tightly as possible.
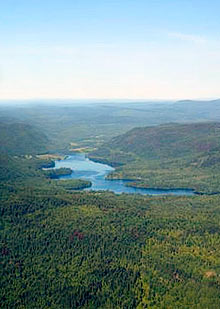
[107,123,220,159]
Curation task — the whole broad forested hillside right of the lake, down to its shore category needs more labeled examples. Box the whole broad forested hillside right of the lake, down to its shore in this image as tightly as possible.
[90,122,220,193]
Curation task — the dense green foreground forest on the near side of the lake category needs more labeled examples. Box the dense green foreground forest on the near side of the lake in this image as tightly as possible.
[0,153,220,309]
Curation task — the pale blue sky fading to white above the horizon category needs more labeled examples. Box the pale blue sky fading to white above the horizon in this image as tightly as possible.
[0,0,220,100]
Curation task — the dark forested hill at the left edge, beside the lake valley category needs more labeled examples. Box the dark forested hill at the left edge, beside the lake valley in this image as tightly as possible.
[0,122,48,155]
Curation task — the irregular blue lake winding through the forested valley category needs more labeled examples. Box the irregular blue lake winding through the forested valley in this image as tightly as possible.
[55,153,194,195]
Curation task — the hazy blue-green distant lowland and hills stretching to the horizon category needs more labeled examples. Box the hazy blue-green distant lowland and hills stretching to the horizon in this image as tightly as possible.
[0,100,220,149]
